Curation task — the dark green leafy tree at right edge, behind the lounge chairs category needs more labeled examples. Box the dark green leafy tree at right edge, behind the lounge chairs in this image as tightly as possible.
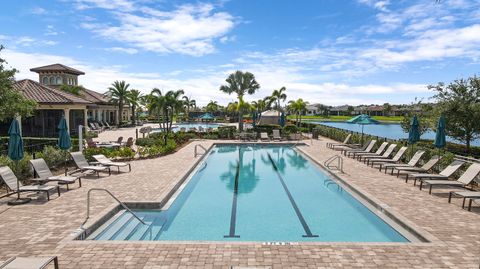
[428,76,480,151]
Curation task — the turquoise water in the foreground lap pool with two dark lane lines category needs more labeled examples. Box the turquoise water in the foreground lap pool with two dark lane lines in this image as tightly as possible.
[94,145,408,242]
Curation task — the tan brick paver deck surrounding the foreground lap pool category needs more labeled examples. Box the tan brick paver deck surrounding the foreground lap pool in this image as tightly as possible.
[0,139,480,268]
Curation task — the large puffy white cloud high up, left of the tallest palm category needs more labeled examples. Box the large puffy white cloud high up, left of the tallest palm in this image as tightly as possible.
[81,1,235,56]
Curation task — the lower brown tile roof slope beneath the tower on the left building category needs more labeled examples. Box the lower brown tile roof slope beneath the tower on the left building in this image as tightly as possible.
[13,79,92,105]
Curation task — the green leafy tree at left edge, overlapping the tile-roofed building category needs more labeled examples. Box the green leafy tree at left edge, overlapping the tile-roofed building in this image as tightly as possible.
[0,45,37,122]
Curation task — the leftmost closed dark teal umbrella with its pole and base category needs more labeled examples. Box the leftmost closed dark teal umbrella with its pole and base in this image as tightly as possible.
[8,119,30,205]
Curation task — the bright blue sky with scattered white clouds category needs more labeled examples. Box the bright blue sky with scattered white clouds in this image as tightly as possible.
[0,0,480,105]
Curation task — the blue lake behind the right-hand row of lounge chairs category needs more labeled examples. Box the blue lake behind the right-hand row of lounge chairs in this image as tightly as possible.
[309,121,480,146]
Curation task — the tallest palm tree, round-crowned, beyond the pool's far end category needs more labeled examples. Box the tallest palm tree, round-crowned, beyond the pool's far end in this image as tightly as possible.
[220,71,260,131]
